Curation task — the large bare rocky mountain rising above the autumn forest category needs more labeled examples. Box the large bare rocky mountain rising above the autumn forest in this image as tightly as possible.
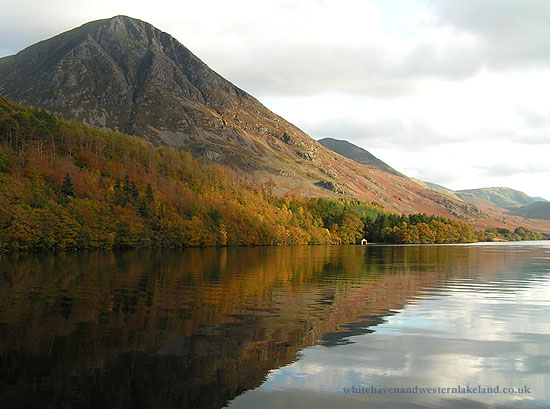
[0,16,548,228]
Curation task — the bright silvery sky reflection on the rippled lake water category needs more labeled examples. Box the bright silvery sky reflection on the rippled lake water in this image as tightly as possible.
[229,242,550,409]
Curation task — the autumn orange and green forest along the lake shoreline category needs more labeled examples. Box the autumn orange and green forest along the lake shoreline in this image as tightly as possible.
[0,97,550,252]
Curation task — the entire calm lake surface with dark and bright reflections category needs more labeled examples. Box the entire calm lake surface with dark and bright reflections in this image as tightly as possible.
[0,242,550,409]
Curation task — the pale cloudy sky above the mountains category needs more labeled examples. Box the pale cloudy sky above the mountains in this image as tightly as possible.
[0,0,550,200]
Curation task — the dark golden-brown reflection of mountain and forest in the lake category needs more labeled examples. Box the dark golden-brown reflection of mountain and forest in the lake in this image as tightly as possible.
[0,246,544,409]
